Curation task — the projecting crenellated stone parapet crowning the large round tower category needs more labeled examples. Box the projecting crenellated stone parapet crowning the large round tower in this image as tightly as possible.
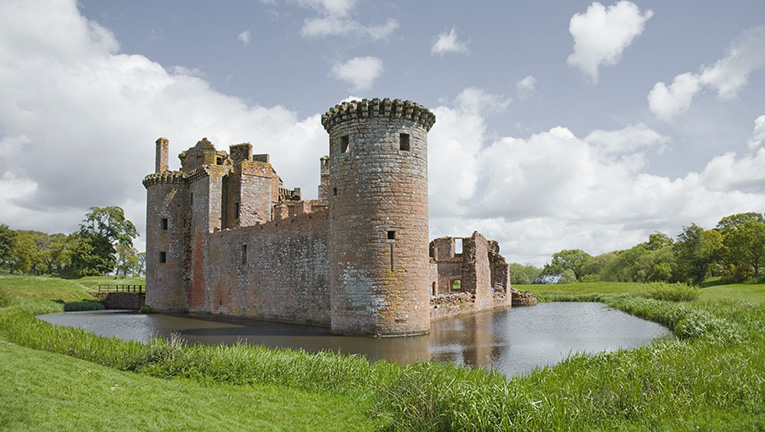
[321,98,436,131]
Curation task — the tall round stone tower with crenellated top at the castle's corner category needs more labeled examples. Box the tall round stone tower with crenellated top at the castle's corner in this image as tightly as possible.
[321,99,435,336]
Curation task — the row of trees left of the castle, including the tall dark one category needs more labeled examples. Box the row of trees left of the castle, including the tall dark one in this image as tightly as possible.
[0,206,140,277]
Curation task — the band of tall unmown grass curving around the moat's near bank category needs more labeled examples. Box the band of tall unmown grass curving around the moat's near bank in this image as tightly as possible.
[0,278,765,431]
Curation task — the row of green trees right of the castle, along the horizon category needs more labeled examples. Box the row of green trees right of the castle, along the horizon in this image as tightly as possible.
[510,212,765,284]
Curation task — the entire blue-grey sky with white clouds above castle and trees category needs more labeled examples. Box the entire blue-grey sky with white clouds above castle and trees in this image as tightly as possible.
[0,0,765,266]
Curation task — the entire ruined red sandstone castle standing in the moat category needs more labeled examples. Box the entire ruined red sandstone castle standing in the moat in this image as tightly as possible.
[143,99,511,336]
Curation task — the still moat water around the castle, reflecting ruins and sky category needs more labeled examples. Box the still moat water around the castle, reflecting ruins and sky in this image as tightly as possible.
[39,303,671,376]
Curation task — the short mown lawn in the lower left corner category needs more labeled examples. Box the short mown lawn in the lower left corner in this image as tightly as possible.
[0,342,374,431]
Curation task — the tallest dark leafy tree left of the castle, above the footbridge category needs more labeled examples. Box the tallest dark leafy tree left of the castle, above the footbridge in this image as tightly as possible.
[71,206,138,276]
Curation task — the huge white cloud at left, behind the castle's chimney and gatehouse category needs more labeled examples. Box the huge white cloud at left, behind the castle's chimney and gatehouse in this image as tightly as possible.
[0,0,327,243]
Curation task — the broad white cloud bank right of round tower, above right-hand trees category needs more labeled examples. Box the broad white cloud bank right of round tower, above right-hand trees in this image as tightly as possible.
[428,89,765,265]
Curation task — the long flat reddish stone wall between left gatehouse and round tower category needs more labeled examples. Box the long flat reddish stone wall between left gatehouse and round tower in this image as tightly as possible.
[203,209,330,326]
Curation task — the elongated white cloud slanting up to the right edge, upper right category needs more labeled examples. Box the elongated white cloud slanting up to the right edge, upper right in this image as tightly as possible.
[648,26,765,121]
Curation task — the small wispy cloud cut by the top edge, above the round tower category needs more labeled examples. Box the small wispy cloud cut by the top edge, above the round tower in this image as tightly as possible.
[294,0,398,40]
